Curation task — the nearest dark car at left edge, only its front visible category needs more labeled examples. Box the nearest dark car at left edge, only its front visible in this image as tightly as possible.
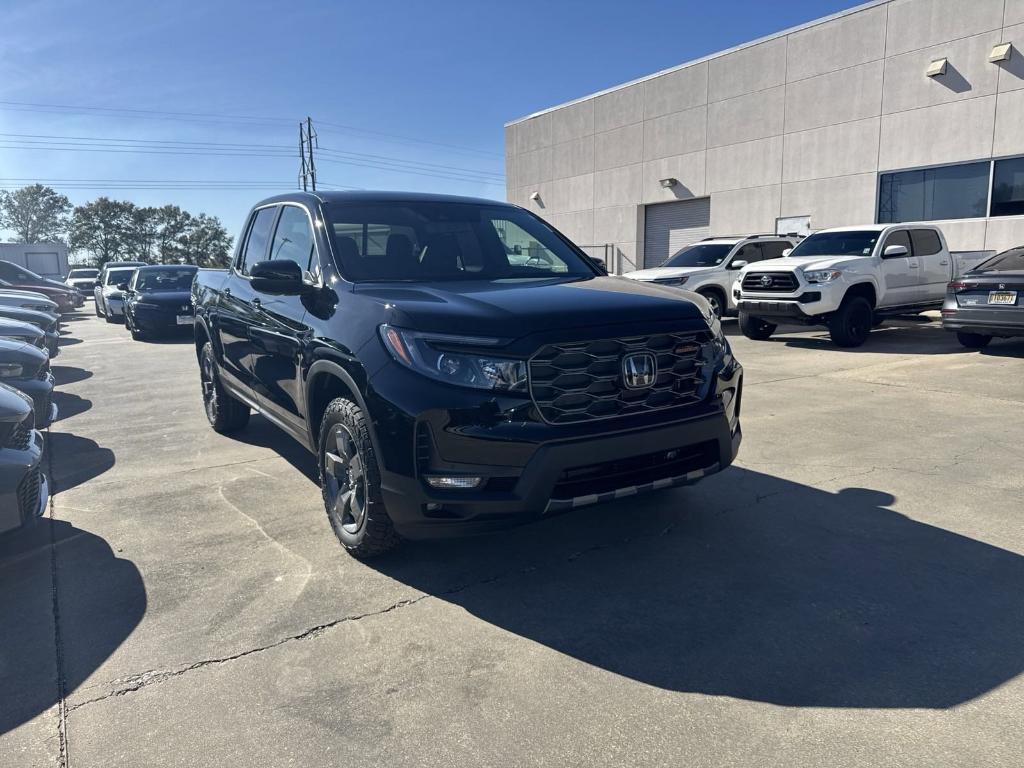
[0,384,49,534]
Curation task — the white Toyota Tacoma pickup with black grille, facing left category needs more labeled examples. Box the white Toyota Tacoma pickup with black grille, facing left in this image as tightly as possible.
[732,223,953,347]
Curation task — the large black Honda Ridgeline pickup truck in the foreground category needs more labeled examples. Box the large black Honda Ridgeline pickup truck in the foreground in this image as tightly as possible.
[193,193,742,557]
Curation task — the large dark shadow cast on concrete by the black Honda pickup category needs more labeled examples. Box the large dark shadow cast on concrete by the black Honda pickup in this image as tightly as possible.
[371,468,1024,709]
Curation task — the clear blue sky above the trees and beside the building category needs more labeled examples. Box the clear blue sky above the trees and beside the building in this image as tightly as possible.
[0,0,854,240]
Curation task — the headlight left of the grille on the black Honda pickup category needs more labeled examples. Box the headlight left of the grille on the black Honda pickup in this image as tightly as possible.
[380,325,526,392]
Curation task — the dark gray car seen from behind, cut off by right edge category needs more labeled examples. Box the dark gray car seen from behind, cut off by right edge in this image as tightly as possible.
[942,246,1024,349]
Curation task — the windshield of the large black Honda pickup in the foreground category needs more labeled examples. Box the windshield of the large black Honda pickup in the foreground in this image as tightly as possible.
[325,201,595,282]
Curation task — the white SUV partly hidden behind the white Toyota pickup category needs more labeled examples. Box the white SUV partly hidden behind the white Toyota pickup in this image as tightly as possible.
[623,234,798,316]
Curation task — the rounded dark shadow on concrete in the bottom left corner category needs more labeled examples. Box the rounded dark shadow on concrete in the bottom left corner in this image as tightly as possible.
[0,518,146,734]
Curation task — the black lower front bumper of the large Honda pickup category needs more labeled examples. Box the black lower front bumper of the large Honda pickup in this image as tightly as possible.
[375,361,742,539]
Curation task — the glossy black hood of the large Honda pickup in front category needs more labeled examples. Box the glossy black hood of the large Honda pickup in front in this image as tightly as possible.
[354,276,703,339]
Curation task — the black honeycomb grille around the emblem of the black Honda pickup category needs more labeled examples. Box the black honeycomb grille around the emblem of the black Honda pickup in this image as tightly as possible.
[529,332,711,424]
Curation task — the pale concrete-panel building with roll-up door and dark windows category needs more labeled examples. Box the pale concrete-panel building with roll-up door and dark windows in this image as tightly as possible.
[505,0,1024,269]
